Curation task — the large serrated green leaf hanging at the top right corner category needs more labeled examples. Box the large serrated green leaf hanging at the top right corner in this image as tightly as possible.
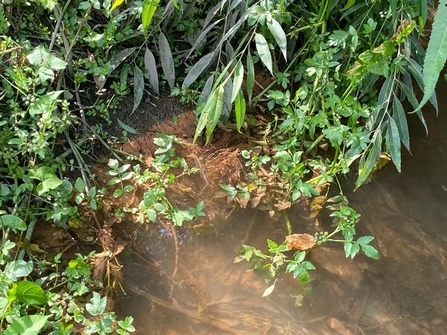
[416,0,447,110]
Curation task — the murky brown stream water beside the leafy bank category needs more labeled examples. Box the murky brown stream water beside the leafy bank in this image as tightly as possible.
[117,90,447,335]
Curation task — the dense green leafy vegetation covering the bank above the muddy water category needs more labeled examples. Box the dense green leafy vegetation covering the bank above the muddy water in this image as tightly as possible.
[0,0,447,334]
